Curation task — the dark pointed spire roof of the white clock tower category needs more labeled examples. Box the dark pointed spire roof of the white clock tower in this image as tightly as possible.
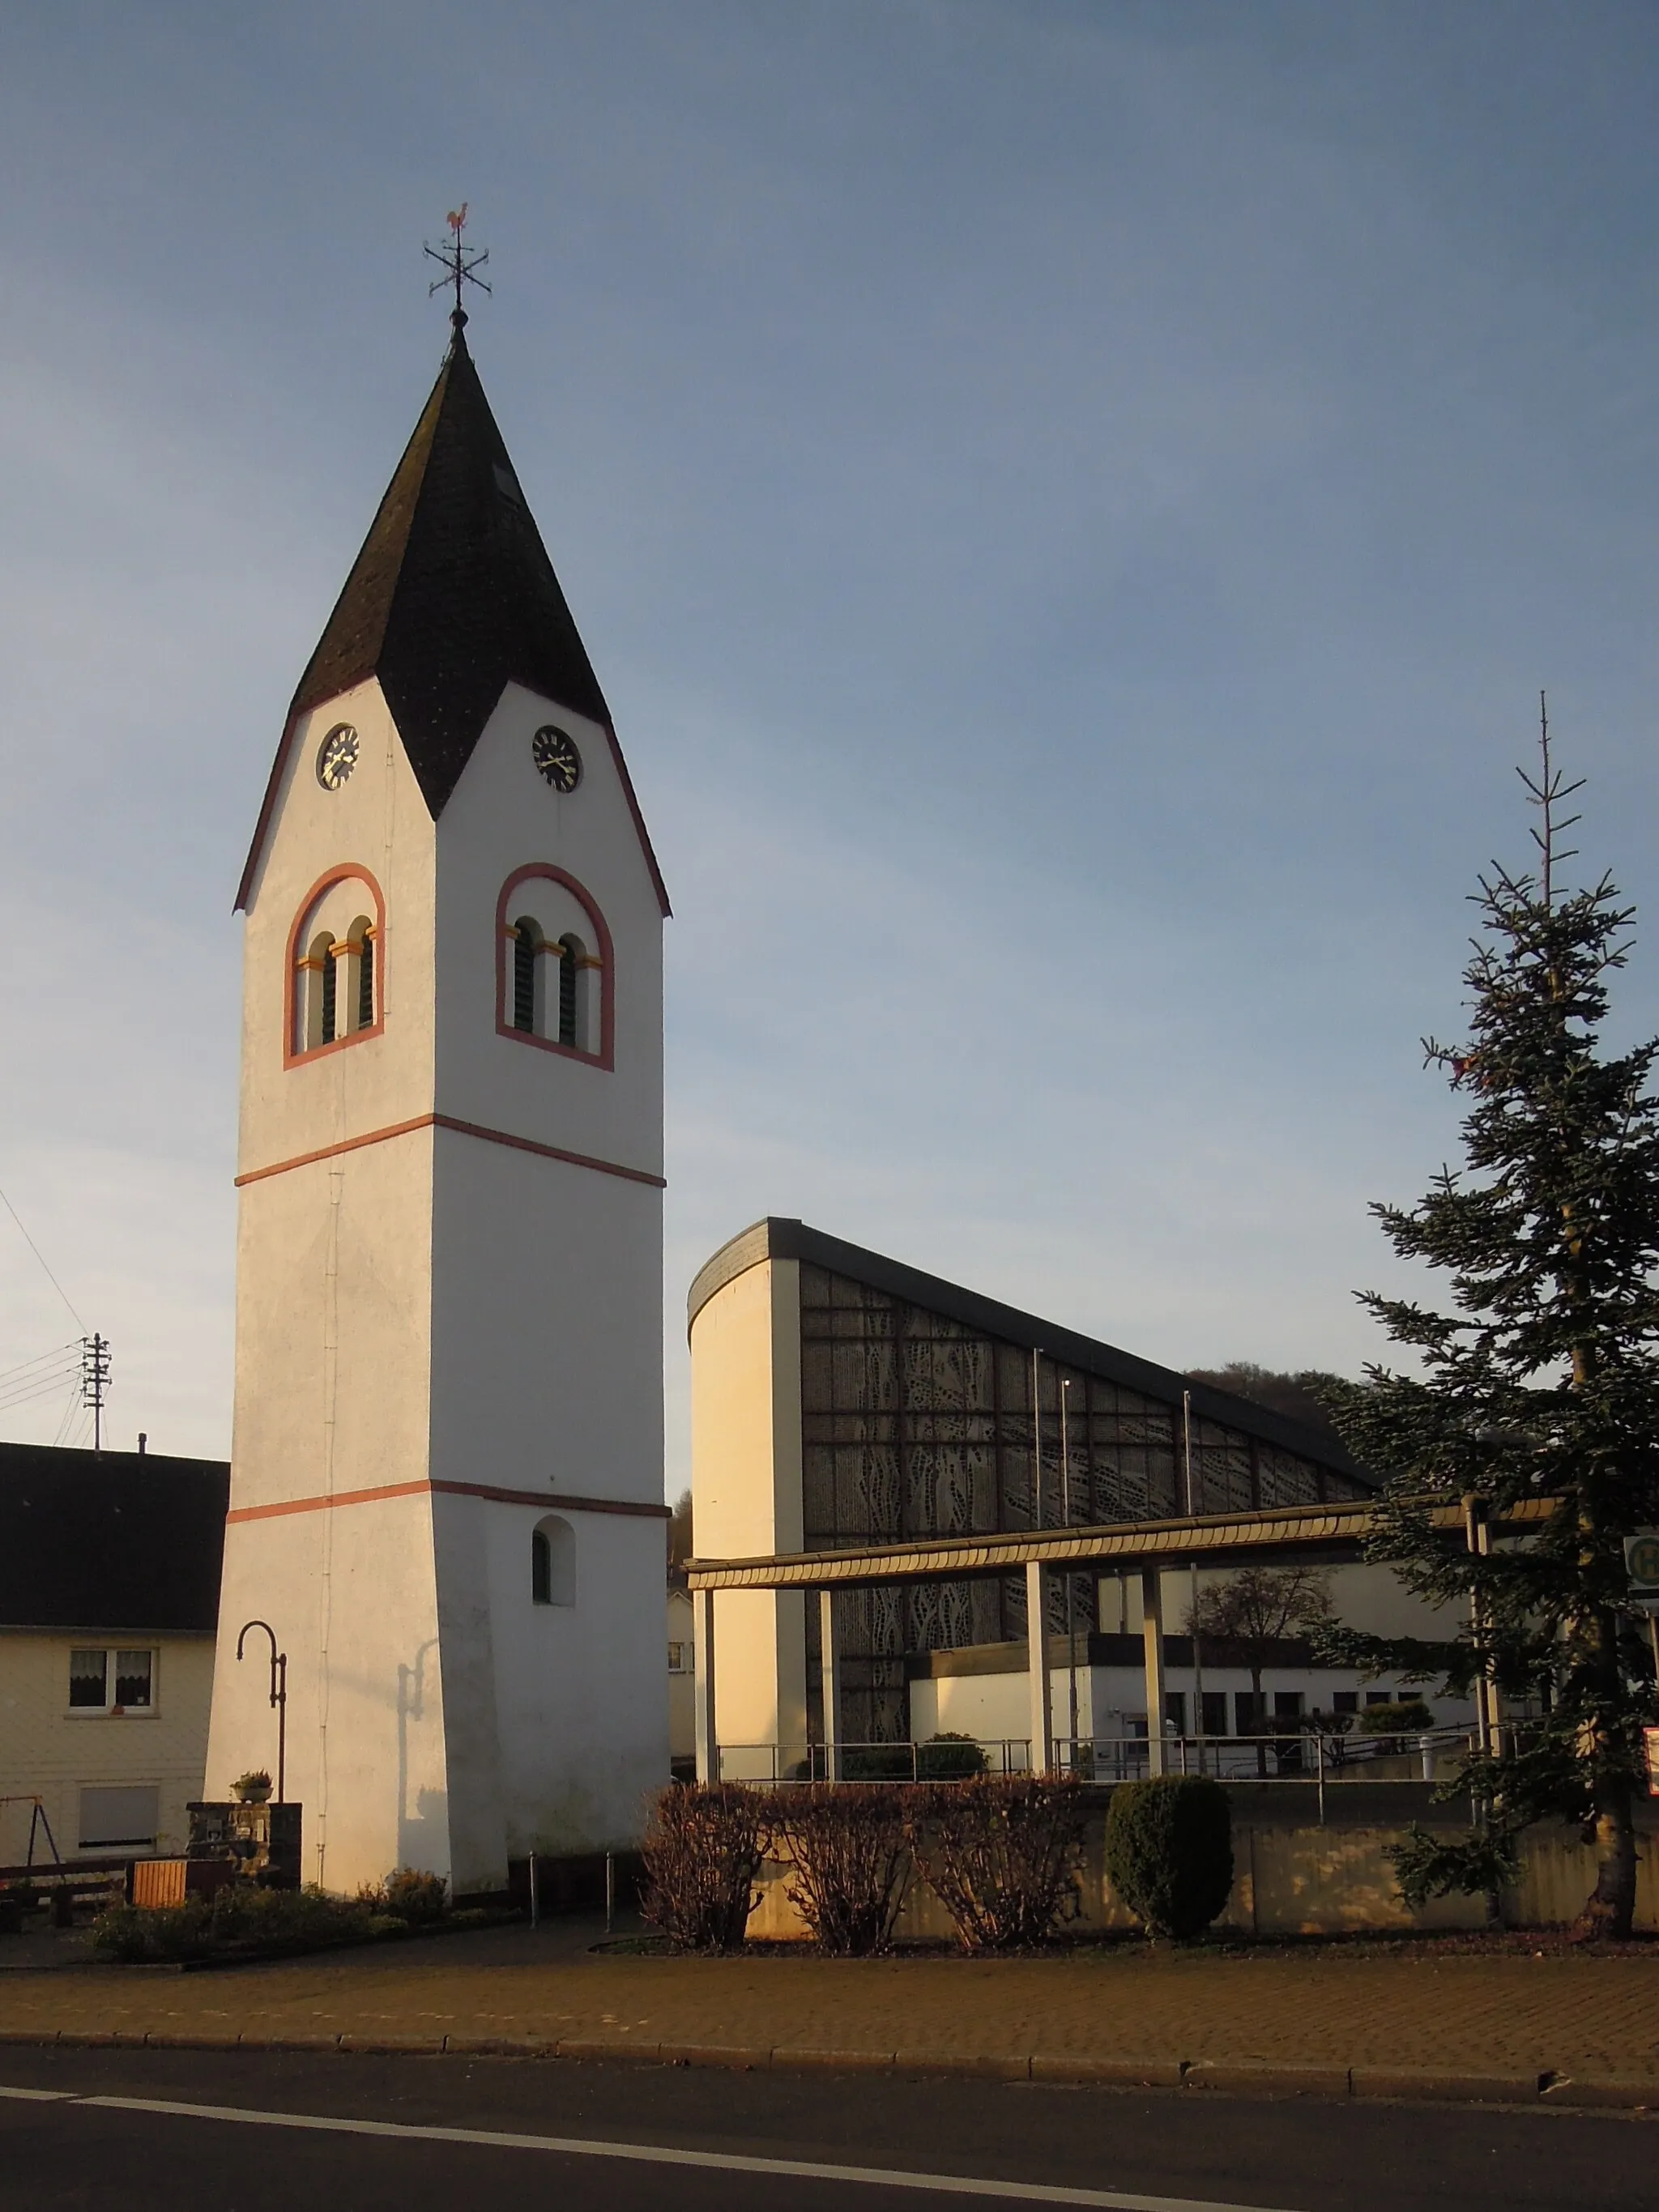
[237,327,668,914]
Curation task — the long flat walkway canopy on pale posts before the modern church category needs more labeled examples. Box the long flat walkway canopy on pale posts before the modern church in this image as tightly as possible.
[686,1498,1555,1780]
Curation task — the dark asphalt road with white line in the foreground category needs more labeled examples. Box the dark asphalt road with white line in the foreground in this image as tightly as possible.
[0,2046,1659,2212]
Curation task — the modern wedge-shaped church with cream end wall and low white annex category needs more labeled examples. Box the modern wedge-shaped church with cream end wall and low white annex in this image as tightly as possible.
[688,1219,1462,1779]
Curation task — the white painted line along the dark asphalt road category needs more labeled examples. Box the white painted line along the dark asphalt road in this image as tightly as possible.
[0,2086,1309,2212]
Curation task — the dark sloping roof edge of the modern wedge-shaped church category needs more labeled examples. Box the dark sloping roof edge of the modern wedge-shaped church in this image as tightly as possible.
[686,1214,1375,1489]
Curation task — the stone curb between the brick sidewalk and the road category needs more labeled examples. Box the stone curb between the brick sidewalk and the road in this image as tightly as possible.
[0,2028,1659,2112]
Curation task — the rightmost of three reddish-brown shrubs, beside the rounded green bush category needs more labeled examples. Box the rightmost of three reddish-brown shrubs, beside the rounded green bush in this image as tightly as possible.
[907,1774,1084,1951]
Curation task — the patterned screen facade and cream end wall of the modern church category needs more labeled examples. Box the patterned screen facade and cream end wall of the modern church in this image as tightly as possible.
[690,1219,1369,1745]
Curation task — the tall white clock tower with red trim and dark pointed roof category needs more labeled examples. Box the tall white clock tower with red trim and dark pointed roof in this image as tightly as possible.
[206,318,668,1894]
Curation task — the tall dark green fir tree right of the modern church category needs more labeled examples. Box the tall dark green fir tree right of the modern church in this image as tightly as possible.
[1323,719,1659,1937]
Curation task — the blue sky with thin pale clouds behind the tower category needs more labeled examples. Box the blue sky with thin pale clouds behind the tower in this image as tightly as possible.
[0,0,1659,1486]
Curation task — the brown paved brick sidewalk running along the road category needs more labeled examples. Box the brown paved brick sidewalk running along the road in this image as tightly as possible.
[0,1922,1659,2103]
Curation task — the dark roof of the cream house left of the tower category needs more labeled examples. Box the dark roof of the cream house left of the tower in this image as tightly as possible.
[0,1444,230,1634]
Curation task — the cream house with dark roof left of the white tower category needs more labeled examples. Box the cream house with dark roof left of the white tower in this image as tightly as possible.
[0,1444,228,1865]
